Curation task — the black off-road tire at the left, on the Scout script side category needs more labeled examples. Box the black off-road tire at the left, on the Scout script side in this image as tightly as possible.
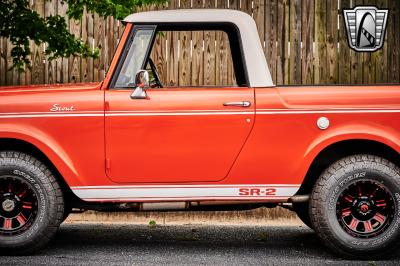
[0,151,64,255]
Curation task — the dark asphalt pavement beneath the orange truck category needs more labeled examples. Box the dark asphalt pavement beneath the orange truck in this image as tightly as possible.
[0,224,400,266]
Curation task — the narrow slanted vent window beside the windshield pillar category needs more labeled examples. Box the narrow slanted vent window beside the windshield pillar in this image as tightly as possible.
[114,28,154,88]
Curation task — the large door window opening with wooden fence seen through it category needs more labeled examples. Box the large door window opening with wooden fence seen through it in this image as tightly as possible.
[147,29,240,87]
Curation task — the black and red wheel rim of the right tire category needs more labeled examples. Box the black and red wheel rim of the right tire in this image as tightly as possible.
[336,180,395,238]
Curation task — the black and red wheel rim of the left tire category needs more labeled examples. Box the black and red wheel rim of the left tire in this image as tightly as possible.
[0,176,38,235]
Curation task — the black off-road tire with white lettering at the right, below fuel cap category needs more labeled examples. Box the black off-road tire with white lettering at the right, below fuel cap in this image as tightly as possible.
[310,155,400,260]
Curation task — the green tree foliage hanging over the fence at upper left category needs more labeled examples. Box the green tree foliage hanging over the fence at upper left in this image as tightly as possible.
[0,0,167,71]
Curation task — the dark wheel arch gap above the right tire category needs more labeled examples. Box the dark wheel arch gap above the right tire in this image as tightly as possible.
[296,138,400,195]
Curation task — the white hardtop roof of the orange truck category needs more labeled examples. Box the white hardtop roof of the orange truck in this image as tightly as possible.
[124,9,273,87]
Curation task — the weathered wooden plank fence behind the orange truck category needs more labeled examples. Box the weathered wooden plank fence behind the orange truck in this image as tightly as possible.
[0,0,400,85]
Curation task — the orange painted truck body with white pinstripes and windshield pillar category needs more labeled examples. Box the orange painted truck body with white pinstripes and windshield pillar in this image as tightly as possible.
[0,25,400,201]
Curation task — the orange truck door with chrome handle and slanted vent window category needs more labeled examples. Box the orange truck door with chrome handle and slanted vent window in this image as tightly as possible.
[105,26,255,183]
